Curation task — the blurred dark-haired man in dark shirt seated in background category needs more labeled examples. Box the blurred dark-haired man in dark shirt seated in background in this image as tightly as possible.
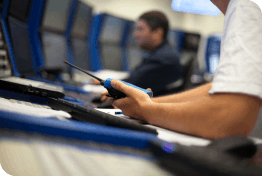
[93,11,183,95]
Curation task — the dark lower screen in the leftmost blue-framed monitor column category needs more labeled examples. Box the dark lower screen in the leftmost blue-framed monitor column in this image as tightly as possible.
[8,17,34,75]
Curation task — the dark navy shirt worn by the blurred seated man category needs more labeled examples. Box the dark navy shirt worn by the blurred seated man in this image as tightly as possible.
[124,41,183,94]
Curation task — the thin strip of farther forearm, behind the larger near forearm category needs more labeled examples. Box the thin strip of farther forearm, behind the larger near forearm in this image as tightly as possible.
[152,83,212,103]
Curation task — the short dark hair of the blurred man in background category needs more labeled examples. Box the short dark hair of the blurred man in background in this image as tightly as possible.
[139,11,169,40]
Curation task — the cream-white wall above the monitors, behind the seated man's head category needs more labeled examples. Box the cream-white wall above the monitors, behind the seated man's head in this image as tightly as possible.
[82,0,224,35]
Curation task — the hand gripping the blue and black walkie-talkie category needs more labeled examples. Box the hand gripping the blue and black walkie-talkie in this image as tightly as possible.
[111,80,153,120]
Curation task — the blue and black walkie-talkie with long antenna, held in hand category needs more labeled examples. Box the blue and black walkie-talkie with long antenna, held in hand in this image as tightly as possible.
[64,61,153,100]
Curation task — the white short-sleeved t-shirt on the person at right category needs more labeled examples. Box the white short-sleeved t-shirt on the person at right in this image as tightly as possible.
[209,0,262,99]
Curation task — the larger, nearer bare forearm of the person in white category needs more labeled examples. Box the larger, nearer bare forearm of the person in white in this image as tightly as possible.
[142,94,260,139]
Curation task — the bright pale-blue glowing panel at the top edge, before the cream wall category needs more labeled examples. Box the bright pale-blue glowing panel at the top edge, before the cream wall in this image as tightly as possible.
[171,0,221,16]
